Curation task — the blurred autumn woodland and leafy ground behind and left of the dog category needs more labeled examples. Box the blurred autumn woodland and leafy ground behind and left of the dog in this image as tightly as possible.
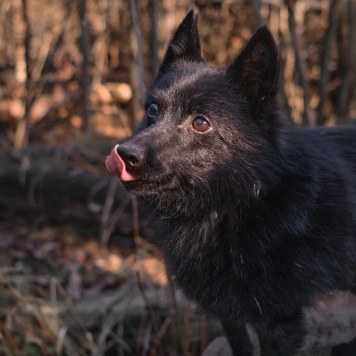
[0,0,356,355]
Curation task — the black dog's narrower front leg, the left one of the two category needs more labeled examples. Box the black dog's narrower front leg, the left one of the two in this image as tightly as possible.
[221,321,253,356]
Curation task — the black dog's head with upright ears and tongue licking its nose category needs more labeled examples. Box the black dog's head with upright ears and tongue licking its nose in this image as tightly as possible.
[107,10,286,217]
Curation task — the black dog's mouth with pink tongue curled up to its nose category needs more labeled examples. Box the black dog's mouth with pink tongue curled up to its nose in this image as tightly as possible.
[105,145,171,195]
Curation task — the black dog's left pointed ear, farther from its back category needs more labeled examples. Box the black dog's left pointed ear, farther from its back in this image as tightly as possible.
[159,8,203,73]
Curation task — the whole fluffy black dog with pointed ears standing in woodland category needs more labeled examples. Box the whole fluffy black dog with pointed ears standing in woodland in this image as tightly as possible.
[106,9,356,356]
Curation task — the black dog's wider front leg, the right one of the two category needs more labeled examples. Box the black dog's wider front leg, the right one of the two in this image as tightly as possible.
[257,311,306,356]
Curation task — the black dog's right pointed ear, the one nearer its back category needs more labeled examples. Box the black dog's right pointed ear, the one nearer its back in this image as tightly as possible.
[227,26,279,103]
